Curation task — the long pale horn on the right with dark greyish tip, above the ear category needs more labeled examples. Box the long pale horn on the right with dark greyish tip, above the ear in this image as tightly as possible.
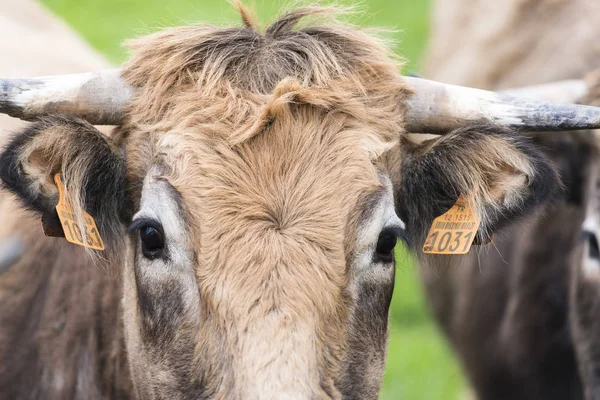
[404,77,600,134]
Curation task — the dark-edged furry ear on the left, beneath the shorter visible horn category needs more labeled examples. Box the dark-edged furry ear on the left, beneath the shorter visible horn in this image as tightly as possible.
[0,117,126,244]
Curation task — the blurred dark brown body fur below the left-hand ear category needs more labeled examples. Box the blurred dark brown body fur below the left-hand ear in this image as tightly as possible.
[0,230,131,400]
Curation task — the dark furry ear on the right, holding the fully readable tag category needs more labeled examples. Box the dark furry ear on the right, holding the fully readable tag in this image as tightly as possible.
[392,126,560,248]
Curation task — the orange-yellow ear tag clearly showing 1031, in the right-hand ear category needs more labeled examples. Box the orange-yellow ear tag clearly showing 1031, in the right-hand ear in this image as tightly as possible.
[423,196,481,254]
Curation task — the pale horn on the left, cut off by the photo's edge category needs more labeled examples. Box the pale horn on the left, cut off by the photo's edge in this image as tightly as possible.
[0,69,134,125]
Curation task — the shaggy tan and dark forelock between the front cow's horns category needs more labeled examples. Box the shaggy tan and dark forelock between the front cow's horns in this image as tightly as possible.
[123,3,410,131]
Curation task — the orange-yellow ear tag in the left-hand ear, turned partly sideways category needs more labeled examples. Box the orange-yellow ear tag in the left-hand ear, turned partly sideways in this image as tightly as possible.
[54,174,104,250]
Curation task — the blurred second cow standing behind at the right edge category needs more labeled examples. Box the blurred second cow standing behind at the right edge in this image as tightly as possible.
[420,0,600,400]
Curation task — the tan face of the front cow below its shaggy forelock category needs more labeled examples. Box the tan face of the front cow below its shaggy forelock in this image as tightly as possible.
[119,103,404,398]
